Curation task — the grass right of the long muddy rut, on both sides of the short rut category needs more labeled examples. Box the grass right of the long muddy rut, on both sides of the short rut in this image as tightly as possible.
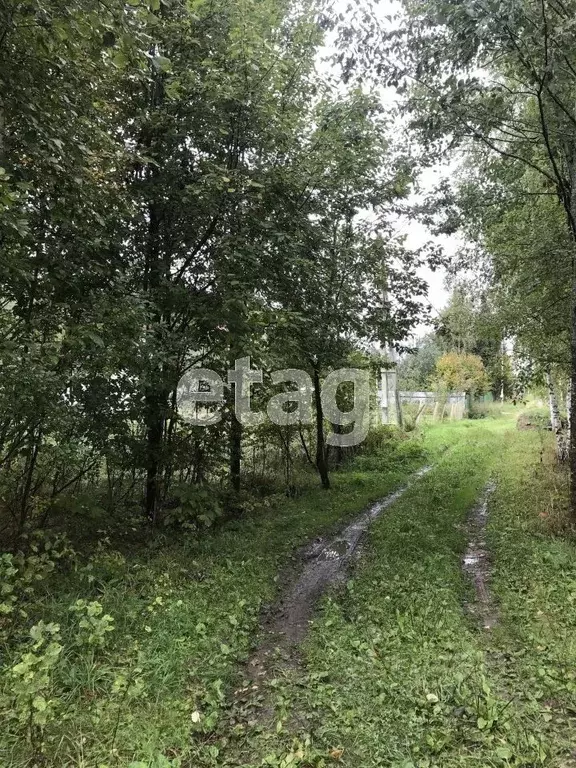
[214,420,576,768]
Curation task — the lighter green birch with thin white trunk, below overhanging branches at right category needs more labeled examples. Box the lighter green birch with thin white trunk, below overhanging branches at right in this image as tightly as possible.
[460,157,572,452]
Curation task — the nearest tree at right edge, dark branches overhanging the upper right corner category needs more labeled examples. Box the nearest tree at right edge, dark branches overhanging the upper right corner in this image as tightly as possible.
[387,0,576,517]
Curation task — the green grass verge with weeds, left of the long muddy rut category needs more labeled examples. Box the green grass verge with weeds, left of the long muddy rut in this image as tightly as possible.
[0,430,459,768]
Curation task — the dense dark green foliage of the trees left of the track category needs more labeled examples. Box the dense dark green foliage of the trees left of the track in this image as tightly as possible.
[0,0,429,540]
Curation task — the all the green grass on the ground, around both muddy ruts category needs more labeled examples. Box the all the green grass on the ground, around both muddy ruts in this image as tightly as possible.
[7,414,576,768]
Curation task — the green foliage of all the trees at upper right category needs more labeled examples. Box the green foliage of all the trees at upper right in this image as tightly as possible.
[386,0,576,394]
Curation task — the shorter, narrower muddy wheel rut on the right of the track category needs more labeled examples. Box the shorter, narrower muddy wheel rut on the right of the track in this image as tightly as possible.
[462,481,498,629]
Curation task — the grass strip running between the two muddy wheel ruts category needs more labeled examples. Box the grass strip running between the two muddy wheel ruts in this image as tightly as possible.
[216,422,509,768]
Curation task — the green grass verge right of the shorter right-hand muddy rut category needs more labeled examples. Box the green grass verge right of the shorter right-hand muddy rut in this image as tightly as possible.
[489,431,576,768]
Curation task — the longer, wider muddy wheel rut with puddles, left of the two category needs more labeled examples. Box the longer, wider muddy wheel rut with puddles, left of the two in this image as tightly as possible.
[236,467,432,697]
